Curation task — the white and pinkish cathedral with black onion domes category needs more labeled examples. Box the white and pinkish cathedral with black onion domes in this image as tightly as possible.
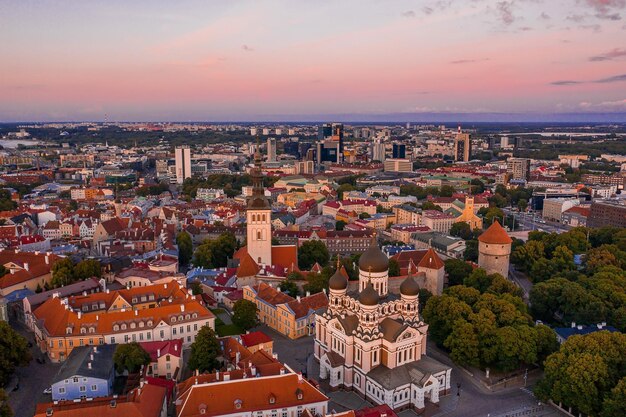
[314,238,451,411]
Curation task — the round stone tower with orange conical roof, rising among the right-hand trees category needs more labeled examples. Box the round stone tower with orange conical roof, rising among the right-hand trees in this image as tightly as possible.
[478,220,513,277]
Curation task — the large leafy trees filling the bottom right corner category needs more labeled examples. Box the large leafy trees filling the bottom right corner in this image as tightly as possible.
[535,331,626,417]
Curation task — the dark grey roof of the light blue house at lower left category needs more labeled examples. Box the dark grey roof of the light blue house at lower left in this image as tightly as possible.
[52,345,117,384]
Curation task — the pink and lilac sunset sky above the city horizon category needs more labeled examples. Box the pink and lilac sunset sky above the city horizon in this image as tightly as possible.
[0,0,626,122]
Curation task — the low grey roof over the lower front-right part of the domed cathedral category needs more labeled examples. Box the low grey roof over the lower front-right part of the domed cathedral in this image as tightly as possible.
[367,356,450,389]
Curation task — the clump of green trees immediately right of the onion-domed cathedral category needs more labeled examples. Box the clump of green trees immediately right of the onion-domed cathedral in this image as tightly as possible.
[423,268,558,372]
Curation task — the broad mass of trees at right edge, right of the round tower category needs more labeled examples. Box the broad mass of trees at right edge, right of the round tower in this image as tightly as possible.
[511,227,626,331]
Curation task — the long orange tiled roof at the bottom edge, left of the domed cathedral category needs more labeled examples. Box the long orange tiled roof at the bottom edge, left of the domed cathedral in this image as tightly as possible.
[176,374,328,417]
